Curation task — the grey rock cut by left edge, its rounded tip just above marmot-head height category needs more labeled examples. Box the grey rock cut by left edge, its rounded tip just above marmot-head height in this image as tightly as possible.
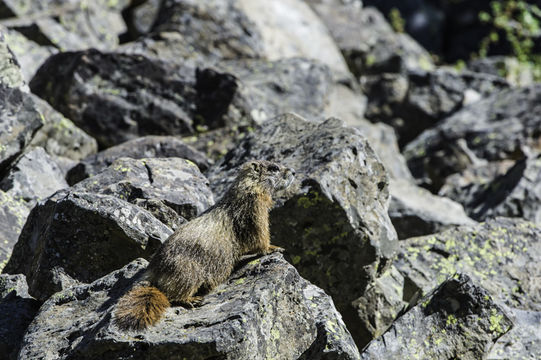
[0,84,43,172]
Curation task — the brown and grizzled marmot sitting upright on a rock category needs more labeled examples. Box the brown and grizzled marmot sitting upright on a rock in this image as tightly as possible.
[114,161,294,330]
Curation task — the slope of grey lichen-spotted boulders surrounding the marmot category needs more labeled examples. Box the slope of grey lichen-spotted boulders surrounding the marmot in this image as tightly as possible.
[0,0,541,360]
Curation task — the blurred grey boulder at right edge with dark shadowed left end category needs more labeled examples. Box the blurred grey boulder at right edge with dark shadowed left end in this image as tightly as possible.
[404,85,541,192]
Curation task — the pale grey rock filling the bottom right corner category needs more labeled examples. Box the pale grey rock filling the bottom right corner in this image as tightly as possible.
[487,309,541,360]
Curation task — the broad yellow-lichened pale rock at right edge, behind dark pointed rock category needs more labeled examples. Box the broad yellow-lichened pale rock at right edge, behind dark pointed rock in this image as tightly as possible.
[394,218,541,311]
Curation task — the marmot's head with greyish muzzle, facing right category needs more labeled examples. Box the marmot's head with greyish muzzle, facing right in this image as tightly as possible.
[238,160,295,194]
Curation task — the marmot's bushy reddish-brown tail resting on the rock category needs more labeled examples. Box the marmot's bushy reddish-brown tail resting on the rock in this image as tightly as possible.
[115,286,171,330]
